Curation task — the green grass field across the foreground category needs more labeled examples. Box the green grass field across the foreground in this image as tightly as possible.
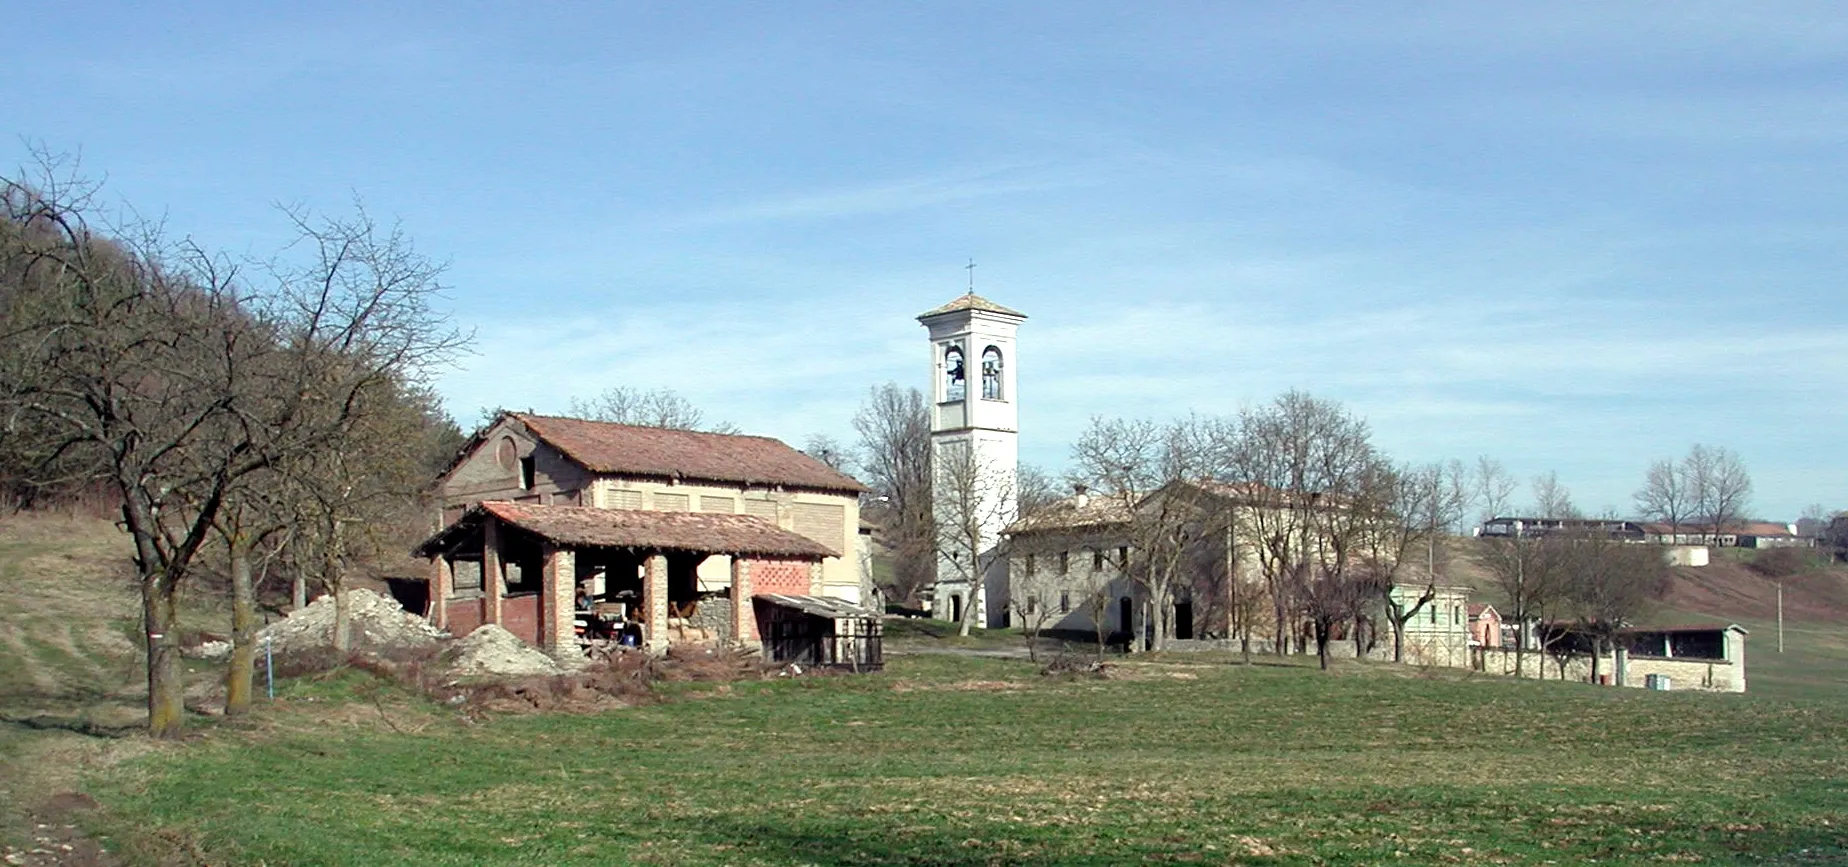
[92,656,1848,865]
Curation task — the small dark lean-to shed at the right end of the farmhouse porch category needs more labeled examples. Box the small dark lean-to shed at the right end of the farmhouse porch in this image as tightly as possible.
[752,593,885,671]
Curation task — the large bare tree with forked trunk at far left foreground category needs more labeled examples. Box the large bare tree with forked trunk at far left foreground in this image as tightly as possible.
[0,162,464,736]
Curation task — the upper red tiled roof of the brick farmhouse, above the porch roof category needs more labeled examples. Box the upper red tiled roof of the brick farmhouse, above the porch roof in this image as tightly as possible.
[508,412,867,494]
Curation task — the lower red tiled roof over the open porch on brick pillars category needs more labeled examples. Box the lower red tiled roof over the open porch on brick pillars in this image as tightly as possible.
[416,501,841,560]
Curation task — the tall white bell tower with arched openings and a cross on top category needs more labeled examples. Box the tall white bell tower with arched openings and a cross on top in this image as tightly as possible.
[918,292,1027,627]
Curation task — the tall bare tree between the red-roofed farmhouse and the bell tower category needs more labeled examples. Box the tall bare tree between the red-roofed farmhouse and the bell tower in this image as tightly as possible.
[854,383,937,603]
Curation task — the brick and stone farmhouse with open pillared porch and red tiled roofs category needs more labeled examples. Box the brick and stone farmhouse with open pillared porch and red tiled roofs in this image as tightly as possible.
[416,412,869,653]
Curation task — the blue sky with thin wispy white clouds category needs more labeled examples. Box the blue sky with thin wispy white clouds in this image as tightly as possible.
[0,2,1848,519]
